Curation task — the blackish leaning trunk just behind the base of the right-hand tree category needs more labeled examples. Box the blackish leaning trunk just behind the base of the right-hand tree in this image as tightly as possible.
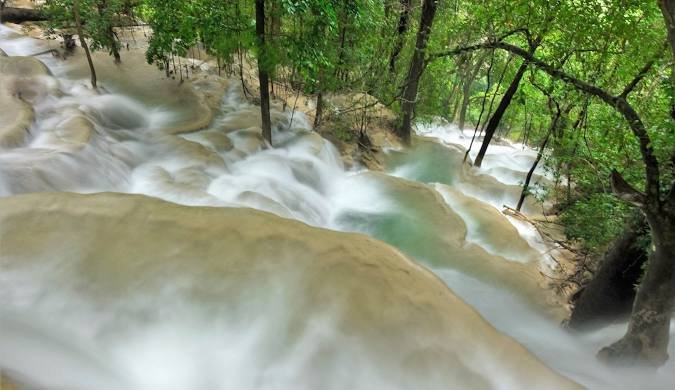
[567,213,649,329]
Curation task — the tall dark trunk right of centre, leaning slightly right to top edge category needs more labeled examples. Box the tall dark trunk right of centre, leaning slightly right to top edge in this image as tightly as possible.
[398,0,437,145]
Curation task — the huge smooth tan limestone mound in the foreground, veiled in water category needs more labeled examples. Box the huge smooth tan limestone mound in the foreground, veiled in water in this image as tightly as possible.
[0,193,578,389]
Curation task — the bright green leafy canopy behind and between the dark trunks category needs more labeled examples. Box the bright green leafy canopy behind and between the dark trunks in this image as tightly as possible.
[55,0,675,253]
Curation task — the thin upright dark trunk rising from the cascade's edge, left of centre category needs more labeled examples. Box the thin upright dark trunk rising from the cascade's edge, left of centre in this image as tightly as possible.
[255,0,272,145]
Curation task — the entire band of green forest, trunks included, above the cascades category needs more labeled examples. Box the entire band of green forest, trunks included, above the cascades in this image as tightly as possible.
[38,0,675,365]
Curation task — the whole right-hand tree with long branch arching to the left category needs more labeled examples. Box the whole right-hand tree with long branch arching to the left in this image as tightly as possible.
[434,31,675,366]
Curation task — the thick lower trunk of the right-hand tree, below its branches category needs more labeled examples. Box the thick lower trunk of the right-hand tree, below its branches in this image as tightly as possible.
[598,210,675,366]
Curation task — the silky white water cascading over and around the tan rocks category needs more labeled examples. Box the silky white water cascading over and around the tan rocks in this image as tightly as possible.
[0,26,675,389]
